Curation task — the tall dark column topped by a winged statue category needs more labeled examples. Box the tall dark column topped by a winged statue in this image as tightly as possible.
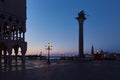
[76,10,86,58]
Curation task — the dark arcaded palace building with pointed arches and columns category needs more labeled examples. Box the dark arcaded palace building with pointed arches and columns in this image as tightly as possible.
[0,0,27,63]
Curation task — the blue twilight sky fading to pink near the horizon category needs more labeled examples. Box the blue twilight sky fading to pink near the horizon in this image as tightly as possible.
[26,0,120,55]
